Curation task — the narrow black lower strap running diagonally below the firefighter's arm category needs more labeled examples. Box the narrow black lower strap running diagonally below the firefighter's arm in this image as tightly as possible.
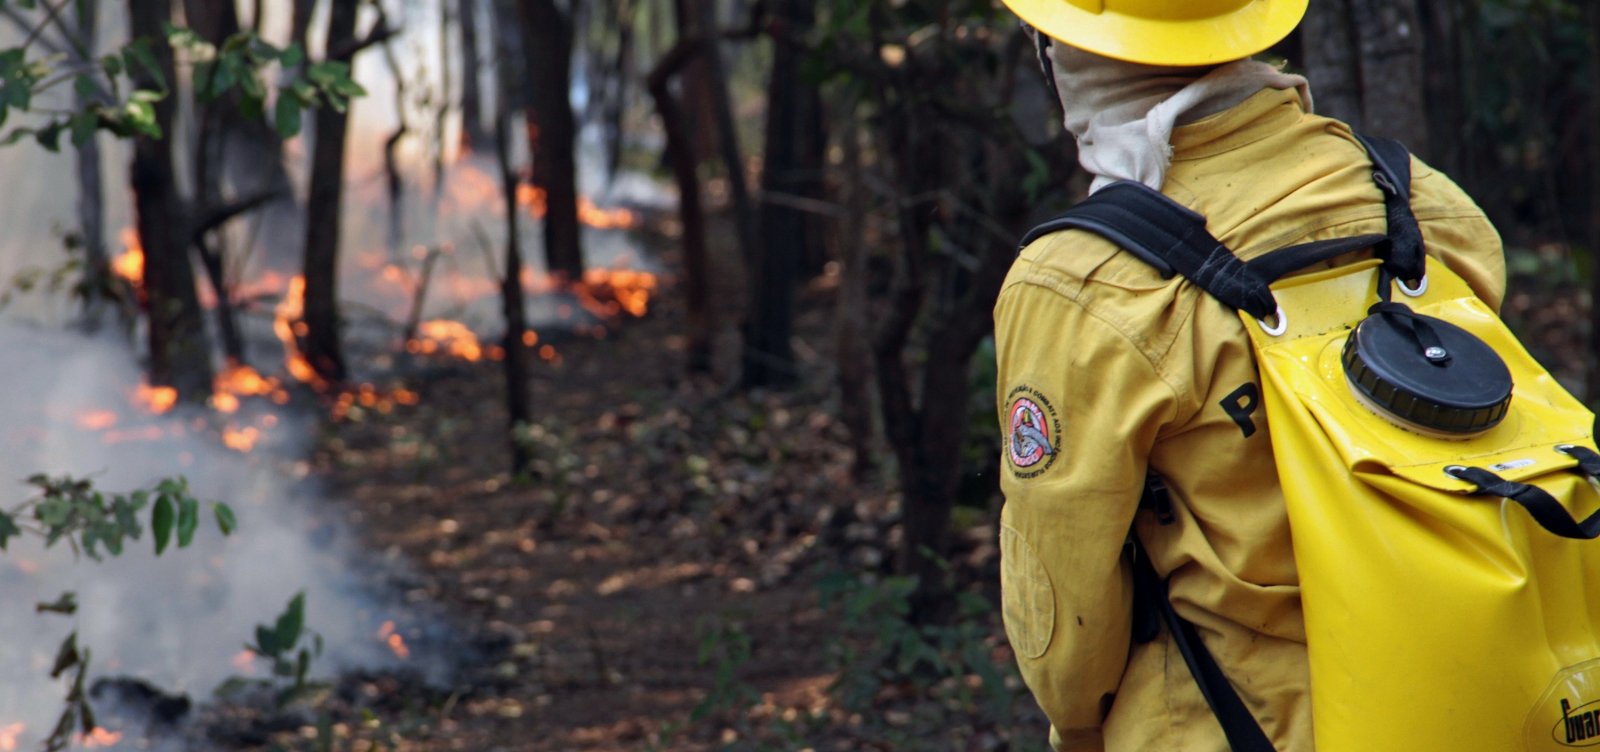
[1128,486,1274,752]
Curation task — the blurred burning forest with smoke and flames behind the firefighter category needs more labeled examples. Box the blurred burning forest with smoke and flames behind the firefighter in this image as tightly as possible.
[0,0,1600,750]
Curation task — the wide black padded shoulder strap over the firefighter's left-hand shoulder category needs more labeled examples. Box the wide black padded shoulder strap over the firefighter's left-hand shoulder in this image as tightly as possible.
[1022,181,1278,318]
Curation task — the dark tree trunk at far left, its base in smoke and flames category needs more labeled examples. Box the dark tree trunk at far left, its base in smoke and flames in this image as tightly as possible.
[128,0,211,402]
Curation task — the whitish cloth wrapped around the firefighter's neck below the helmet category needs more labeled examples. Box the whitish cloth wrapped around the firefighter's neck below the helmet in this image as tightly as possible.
[1050,42,1312,194]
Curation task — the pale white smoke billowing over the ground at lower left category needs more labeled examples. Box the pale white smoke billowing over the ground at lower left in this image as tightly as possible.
[0,325,445,749]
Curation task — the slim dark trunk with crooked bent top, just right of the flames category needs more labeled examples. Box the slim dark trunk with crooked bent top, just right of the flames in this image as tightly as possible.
[645,36,715,373]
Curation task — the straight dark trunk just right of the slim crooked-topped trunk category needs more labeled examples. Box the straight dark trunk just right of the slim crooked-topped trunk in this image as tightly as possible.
[742,0,811,389]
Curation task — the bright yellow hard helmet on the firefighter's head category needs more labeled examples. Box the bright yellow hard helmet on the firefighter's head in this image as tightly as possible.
[1003,0,1307,66]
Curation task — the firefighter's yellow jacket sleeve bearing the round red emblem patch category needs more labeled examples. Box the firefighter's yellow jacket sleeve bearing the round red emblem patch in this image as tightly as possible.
[995,267,1176,750]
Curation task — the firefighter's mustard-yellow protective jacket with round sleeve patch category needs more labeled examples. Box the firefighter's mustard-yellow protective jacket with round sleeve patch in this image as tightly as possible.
[995,90,1504,752]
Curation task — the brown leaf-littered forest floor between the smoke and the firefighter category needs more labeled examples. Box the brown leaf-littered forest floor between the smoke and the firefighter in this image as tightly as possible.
[181,217,1045,752]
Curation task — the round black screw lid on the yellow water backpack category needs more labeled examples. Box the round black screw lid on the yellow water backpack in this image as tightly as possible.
[1341,312,1512,434]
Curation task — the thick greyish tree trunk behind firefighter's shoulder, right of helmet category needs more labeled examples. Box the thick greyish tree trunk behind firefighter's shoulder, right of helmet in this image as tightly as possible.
[1350,0,1429,157]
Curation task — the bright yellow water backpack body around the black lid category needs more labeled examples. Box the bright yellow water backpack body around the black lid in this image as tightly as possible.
[1245,261,1600,752]
